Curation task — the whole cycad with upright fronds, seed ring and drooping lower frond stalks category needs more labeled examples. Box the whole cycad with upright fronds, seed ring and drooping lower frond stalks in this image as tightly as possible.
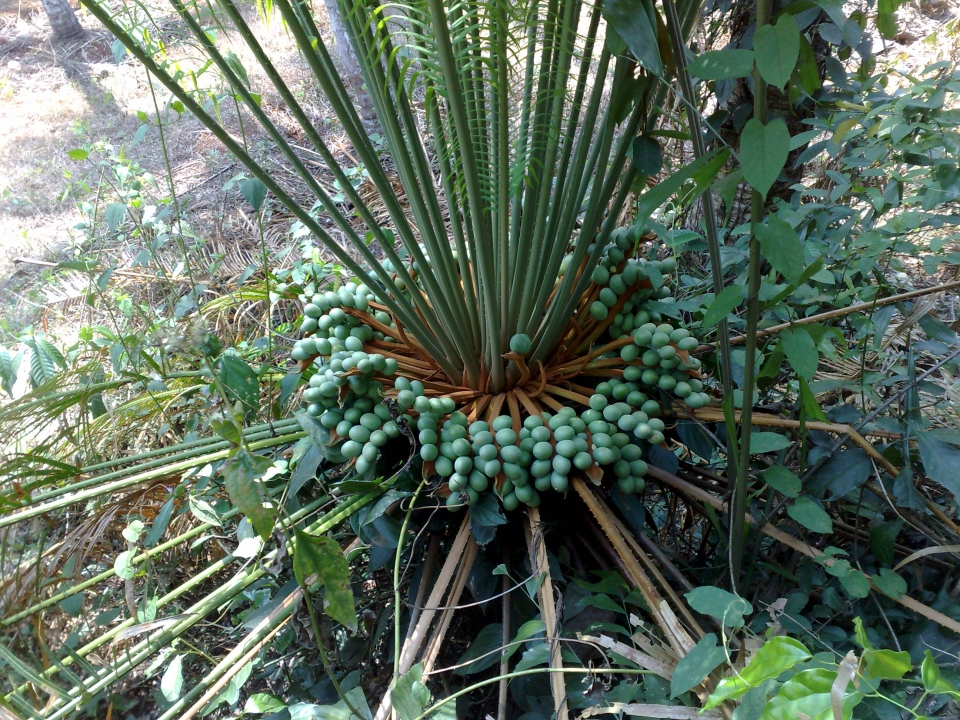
[0,0,725,717]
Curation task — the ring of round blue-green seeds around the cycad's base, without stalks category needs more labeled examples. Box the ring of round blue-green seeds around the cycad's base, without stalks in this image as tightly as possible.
[284,229,709,510]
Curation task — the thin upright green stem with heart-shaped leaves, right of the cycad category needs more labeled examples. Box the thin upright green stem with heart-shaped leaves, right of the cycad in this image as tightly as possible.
[728,0,771,591]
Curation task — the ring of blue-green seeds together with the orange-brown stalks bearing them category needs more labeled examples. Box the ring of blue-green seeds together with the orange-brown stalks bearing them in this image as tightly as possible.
[291,228,710,511]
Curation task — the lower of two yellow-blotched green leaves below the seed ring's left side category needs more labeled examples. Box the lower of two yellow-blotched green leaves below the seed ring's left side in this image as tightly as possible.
[293,527,357,632]
